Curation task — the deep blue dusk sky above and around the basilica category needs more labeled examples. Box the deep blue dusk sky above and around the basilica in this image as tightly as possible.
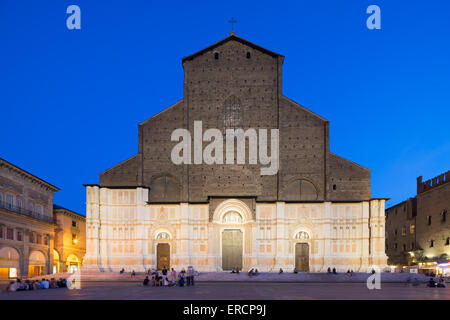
[0,0,450,214]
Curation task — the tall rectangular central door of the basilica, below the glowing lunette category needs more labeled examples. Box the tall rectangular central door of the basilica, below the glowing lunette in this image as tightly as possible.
[222,229,243,271]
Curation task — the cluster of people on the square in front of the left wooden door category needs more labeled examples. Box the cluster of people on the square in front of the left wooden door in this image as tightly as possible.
[143,266,196,287]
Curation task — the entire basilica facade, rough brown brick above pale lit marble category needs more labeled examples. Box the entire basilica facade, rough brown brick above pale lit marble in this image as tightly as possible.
[84,34,387,272]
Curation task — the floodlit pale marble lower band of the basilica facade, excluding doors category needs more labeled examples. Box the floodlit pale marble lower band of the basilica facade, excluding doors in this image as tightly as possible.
[85,186,387,272]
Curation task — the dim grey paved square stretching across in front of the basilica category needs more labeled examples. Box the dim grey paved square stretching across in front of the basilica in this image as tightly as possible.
[0,281,450,300]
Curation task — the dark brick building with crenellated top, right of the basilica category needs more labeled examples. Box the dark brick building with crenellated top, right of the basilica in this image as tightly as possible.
[386,171,450,273]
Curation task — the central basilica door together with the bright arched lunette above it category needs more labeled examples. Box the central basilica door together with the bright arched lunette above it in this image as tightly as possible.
[222,211,244,270]
